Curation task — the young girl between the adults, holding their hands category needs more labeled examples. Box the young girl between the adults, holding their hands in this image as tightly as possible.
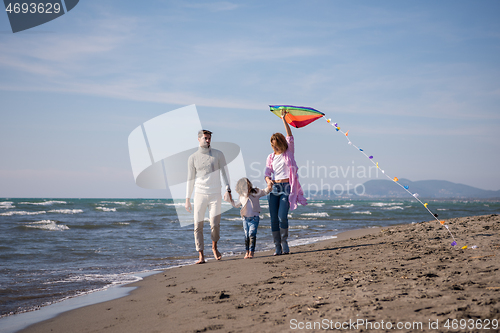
[231,178,272,259]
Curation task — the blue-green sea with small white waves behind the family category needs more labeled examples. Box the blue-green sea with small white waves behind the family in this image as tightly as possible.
[0,198,500,320]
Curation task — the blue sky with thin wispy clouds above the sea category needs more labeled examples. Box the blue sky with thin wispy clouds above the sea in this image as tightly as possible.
[0,0,500,198]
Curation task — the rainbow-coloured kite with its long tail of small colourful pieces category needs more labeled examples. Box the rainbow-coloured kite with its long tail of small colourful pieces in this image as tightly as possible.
[270,105,460,249]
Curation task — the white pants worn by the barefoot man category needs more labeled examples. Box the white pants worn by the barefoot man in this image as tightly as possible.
[194,192,222,251]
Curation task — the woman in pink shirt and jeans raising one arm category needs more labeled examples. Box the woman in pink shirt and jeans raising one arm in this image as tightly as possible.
[265,110,307,255]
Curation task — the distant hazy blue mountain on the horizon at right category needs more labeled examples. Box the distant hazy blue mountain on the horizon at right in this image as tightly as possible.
[357,179,500,199]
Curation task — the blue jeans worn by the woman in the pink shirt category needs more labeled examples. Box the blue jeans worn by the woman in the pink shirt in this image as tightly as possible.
[268,183,290,231]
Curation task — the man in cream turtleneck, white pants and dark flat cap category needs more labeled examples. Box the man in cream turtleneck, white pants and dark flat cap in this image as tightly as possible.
[185,130,231,264]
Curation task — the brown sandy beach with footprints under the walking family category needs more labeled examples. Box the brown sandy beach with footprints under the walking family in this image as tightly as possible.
[17,215,500,333]
